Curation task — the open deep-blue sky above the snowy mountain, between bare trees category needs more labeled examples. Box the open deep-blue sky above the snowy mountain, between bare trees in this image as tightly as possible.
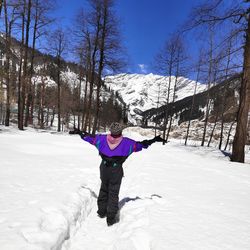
[56,0,201,73]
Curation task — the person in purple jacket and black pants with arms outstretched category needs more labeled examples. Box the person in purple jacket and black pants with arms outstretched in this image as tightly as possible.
[74,122,165,226]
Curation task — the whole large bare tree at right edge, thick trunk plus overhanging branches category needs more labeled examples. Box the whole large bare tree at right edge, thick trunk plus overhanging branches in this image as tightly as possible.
[189,0,250,162]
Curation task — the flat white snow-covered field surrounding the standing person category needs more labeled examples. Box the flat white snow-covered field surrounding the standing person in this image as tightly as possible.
[0,126,250,250]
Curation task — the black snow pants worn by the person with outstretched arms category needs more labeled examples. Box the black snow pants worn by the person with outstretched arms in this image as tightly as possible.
[97,160,123,218]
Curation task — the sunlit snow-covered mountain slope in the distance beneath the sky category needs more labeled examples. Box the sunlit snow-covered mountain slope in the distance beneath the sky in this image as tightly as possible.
[105,74,206,124]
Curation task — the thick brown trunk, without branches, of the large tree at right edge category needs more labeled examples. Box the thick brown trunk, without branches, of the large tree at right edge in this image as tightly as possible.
[231,15,250,162]
